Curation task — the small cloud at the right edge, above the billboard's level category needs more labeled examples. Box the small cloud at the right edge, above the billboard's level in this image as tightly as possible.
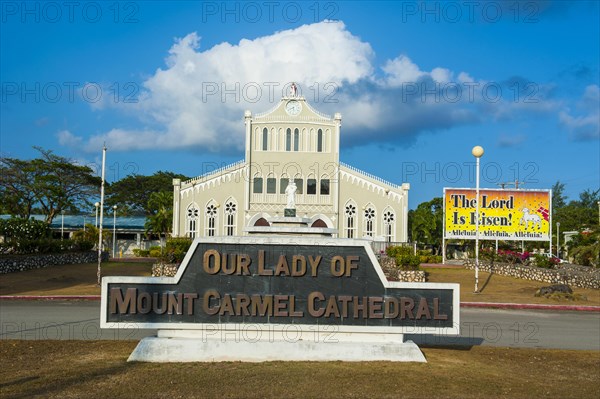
[558,85,600,140]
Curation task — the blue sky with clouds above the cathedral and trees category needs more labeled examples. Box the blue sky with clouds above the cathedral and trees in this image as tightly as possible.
[0,0,600,208]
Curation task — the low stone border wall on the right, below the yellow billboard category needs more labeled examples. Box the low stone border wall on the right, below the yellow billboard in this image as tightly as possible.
[464,259,600,289]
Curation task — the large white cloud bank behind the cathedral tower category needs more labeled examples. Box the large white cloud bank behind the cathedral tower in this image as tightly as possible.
[67,21,568,151]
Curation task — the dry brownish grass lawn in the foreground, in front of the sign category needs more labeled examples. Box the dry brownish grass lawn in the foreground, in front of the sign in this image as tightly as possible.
[0,341,600,399]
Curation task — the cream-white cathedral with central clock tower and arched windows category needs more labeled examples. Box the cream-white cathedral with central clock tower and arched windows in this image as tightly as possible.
[172,87,410,242]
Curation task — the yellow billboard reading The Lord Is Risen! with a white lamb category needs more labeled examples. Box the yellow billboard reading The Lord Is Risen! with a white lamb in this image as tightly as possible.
[444,188,552,241]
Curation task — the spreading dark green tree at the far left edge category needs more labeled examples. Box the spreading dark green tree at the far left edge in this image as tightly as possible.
[0,147,101,223]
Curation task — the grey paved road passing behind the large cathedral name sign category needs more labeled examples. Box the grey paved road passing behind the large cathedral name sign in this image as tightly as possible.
[0,301,600,351]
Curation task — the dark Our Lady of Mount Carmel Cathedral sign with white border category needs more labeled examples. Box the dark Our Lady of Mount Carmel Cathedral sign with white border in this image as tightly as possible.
[101,237,459,334]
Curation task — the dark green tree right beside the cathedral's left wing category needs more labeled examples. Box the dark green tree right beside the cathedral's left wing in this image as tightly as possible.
[106,171,188,216]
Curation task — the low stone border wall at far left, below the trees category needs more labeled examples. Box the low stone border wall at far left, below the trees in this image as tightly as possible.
[0,251,108,274]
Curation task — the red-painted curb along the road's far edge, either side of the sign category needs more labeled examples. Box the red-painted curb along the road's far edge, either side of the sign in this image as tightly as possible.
[0,295,600,312]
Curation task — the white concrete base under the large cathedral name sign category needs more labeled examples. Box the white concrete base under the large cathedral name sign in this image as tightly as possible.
[128,329,427,363]
